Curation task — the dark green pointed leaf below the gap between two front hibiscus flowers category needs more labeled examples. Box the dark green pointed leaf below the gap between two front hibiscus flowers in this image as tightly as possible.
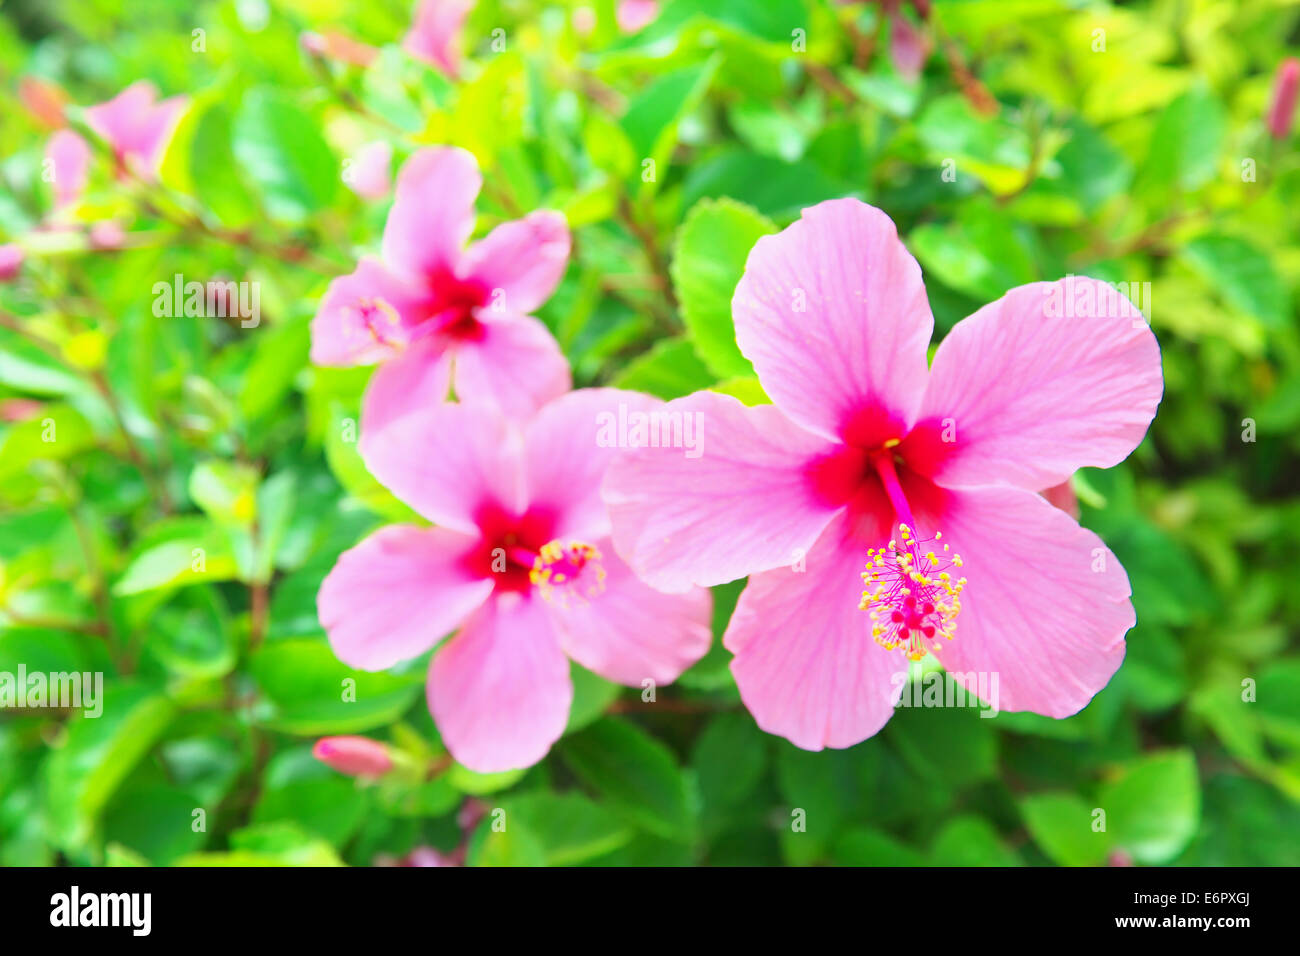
[559,718,694,840]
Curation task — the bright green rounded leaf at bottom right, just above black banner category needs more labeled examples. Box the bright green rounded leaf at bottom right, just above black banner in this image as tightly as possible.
[1099,750,1201,864]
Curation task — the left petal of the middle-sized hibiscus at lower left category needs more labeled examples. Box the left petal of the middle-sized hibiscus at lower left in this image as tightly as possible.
[316,524,493,671]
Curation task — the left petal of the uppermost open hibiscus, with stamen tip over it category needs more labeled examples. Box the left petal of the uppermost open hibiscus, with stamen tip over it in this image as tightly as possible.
[312,259,421,365]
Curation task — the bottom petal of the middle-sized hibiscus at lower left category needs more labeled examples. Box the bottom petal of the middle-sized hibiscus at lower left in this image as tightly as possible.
[429,594,573,774]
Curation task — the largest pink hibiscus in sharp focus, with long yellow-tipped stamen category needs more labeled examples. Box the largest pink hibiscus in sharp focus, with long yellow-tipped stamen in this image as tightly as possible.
[605,199,1162,749]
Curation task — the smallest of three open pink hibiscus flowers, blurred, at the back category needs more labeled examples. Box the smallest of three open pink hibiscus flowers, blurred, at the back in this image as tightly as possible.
[312,147,569,431]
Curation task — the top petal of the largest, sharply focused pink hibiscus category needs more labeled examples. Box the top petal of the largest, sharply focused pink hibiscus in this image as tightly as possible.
[732,199,935,446]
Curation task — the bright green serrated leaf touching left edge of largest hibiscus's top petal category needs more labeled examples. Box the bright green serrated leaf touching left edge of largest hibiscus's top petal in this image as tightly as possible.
[671,199,776,378]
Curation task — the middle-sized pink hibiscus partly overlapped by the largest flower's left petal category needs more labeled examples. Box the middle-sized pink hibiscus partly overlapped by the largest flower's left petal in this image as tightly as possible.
[317,389,711,773]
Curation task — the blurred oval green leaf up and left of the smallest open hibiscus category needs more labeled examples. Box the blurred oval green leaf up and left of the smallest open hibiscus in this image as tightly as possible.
[234,87,342,222]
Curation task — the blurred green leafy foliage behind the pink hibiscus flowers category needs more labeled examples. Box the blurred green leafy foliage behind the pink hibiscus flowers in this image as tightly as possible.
[0,0,1300,865]
